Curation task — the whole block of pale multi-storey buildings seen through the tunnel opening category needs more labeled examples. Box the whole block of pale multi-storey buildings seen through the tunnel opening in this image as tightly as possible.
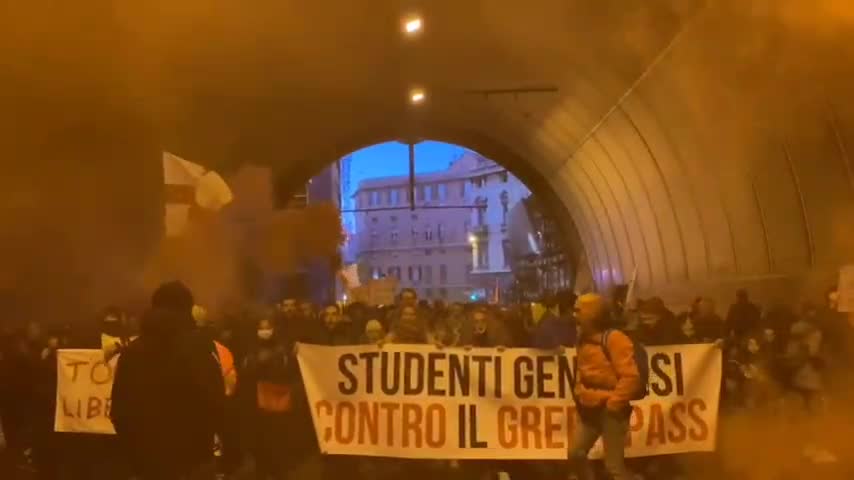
[353,152,529,301]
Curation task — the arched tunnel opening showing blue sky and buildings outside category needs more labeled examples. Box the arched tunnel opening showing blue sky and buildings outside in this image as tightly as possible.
[310,140,592,302]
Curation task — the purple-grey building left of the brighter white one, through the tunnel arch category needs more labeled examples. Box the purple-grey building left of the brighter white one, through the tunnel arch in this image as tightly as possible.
[354,156,471,301]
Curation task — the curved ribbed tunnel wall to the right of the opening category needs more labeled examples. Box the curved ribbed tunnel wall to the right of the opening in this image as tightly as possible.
[412,2,854,299]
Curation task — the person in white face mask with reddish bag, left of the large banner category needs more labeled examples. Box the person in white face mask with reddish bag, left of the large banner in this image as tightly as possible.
[241,318,297,480]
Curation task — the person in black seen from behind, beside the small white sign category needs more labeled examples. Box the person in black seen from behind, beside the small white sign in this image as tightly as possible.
[111,282,225,480]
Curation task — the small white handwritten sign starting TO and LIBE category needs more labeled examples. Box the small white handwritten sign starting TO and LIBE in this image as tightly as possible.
[54,350,118,434]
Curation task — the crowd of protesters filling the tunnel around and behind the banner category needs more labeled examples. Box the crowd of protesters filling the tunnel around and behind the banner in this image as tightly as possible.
[0,282,854,480]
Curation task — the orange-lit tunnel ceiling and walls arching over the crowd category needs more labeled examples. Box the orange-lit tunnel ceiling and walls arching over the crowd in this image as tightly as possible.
[0,0,854,318]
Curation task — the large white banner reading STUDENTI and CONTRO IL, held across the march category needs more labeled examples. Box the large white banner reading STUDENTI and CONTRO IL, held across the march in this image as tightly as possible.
[298,344,721,460]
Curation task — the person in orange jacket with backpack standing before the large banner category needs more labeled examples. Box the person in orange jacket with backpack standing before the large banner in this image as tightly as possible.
[568,294,642,480]
